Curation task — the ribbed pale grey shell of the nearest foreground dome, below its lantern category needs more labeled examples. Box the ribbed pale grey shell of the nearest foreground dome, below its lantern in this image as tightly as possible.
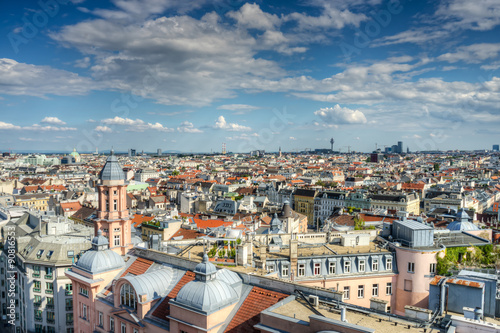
[175,280,238,313]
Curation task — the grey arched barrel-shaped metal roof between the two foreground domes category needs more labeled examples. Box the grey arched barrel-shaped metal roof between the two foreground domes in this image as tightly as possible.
[122,267,174,303]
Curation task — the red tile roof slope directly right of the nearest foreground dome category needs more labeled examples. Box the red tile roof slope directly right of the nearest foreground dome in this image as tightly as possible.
[225,287,288,333]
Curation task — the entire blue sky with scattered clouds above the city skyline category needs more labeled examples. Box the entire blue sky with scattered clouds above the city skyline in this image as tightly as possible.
[0,0,500,152]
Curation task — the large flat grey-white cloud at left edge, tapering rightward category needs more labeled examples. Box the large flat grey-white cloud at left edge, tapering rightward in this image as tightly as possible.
[0,58,95,97]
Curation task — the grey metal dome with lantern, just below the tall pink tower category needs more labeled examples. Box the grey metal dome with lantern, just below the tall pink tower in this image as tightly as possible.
[75,230,125,274]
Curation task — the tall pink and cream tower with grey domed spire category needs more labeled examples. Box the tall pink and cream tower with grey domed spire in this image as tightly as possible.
[94,150,133,255]
